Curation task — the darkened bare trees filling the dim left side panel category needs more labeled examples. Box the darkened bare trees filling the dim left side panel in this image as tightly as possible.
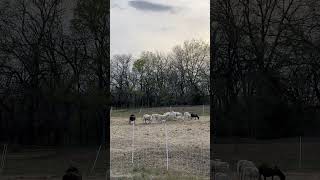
[0,0,110,145]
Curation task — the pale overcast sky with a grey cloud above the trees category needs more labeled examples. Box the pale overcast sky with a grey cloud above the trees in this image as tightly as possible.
[110,0,210,57]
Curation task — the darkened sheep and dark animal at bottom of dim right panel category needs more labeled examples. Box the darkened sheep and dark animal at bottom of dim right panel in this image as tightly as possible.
[211,159,285,180]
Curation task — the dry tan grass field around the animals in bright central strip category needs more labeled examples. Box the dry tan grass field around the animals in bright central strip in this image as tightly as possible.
[111,106,210,179]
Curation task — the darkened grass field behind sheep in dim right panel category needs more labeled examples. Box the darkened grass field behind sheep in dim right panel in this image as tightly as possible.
[213,138,320,180]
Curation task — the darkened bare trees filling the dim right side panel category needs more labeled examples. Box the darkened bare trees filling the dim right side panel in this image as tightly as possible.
[210,0,320,138]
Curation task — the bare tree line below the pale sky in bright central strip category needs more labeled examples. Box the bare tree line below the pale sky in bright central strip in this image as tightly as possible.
[111,39,210,108]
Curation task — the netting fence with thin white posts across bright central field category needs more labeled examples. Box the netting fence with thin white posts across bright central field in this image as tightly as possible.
[111,118,210,178]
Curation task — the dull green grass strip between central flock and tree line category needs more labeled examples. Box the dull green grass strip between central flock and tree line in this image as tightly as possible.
[111,105,210,117]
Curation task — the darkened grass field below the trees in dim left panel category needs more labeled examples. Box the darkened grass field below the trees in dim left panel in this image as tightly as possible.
[0,144,107,179]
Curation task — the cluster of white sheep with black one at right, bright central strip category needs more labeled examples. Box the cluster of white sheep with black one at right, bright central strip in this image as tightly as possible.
[142,111,199,124]
